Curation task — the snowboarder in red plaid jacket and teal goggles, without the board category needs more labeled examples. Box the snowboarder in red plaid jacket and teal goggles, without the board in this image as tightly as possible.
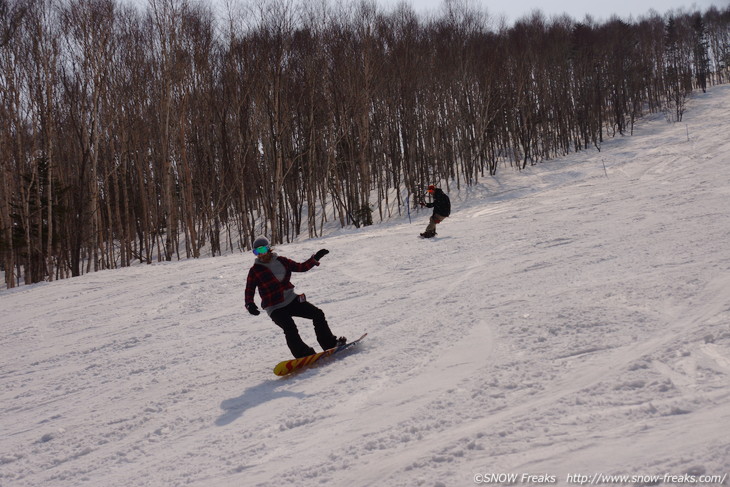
[245,237,347,358]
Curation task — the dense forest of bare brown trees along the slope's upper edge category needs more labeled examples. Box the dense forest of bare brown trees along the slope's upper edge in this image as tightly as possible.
[0,0,730,287]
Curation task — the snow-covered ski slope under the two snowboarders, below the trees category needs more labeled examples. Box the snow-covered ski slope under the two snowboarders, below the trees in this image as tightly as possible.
[0,86,730,487]
